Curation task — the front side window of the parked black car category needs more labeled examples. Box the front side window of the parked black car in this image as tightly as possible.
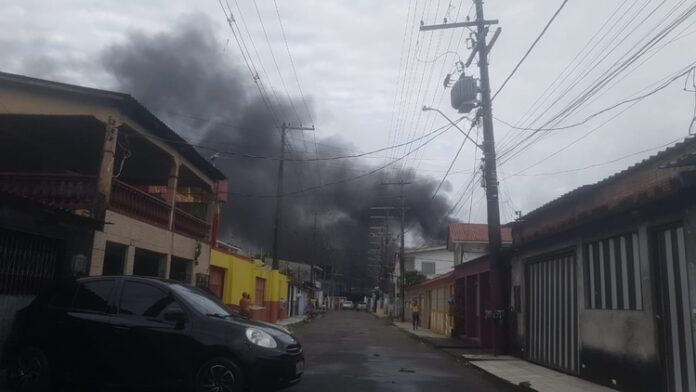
[118,282,174,318]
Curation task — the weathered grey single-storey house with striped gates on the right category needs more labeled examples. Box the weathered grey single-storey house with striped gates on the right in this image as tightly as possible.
[508,137,696,392]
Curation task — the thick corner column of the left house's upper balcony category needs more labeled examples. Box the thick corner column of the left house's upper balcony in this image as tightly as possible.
[93,117,119,220]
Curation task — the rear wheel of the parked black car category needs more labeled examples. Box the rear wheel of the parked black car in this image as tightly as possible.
[7,348,50,392]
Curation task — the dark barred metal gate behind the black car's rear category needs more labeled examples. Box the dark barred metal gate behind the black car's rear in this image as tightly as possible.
[0,229,62,345]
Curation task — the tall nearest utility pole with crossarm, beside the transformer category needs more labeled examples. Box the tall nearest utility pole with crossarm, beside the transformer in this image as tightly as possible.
[420,0,503,354]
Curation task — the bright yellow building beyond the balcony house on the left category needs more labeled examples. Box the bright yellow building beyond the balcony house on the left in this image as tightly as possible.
[210,248,288,322]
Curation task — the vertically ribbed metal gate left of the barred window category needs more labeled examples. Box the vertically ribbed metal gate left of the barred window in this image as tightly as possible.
[526,253,578,373]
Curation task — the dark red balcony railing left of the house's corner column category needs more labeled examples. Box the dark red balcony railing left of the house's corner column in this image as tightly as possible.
[0,173,97,210]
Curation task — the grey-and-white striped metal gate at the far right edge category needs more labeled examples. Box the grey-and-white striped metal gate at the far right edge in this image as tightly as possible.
[656,227,696,392]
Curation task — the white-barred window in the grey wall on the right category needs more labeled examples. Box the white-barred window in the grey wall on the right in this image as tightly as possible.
[584,233,643,310]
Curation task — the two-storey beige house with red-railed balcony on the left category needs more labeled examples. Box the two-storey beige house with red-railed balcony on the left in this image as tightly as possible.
[0,73,226,286]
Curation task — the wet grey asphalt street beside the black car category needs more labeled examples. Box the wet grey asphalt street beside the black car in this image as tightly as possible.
[287,311,515,392]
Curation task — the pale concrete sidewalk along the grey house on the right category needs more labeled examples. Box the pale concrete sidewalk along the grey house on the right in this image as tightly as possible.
[394,322,615,392]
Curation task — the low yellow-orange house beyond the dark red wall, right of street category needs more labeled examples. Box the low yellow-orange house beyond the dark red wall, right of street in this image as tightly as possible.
[404,271,454,336]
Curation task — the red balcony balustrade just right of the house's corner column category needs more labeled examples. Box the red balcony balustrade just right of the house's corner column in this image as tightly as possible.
[109,180,171,230]
